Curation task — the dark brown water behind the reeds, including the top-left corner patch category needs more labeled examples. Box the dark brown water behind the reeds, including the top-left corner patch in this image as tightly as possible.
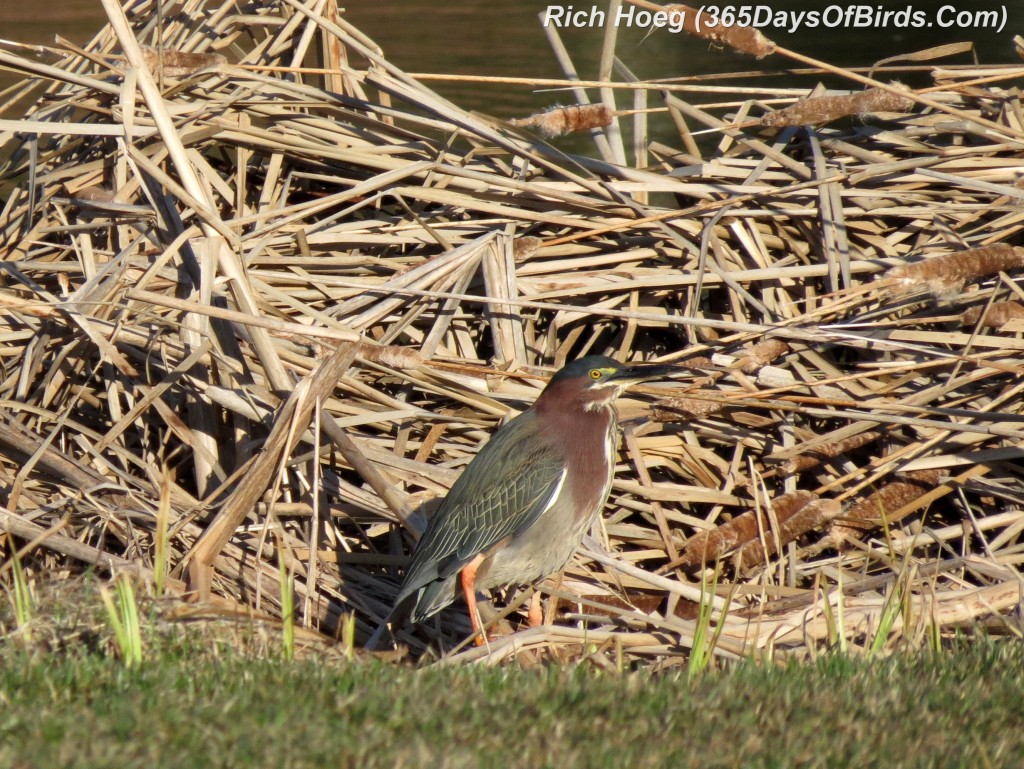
[0,0,1024,127]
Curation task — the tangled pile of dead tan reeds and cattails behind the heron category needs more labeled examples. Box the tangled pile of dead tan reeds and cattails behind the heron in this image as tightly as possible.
[0,0,1024,663]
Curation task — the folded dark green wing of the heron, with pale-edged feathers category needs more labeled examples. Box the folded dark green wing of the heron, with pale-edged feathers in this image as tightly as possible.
[395,411,564,621]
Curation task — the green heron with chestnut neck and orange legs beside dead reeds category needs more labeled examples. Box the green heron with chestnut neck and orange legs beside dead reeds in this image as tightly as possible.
[391,355,678,643]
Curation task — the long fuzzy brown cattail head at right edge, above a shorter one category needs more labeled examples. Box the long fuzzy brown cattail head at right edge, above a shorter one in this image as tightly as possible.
[884,243,1024,297]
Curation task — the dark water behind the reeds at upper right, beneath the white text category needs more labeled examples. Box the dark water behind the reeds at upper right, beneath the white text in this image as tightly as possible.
[347,0,1024,118]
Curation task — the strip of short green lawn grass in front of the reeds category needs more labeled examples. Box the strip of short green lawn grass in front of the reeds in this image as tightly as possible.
[0,642,1024,769]
